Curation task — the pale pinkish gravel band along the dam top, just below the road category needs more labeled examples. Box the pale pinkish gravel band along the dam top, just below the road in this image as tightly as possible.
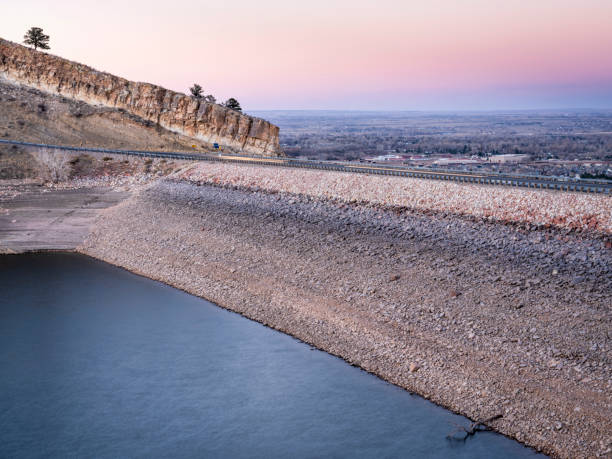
[182,163,612,234]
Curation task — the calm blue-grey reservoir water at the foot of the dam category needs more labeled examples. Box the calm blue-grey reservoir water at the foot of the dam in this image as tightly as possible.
[0,253,538,459]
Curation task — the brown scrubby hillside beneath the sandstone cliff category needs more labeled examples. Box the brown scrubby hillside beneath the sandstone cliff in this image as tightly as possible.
[0,81,206,179]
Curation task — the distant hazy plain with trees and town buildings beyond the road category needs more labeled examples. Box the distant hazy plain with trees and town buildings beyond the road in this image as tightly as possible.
[258,111,612,180]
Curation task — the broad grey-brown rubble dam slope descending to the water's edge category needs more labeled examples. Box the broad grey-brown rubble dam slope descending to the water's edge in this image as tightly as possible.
[80,180,612,458]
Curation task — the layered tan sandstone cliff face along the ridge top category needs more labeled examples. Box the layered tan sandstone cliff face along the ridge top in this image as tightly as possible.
[0,38,283,156]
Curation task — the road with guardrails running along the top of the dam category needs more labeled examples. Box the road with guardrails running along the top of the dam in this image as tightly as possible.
[0,140,612,195]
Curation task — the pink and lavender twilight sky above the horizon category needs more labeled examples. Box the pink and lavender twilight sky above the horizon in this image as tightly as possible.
[0,0,612,111]
